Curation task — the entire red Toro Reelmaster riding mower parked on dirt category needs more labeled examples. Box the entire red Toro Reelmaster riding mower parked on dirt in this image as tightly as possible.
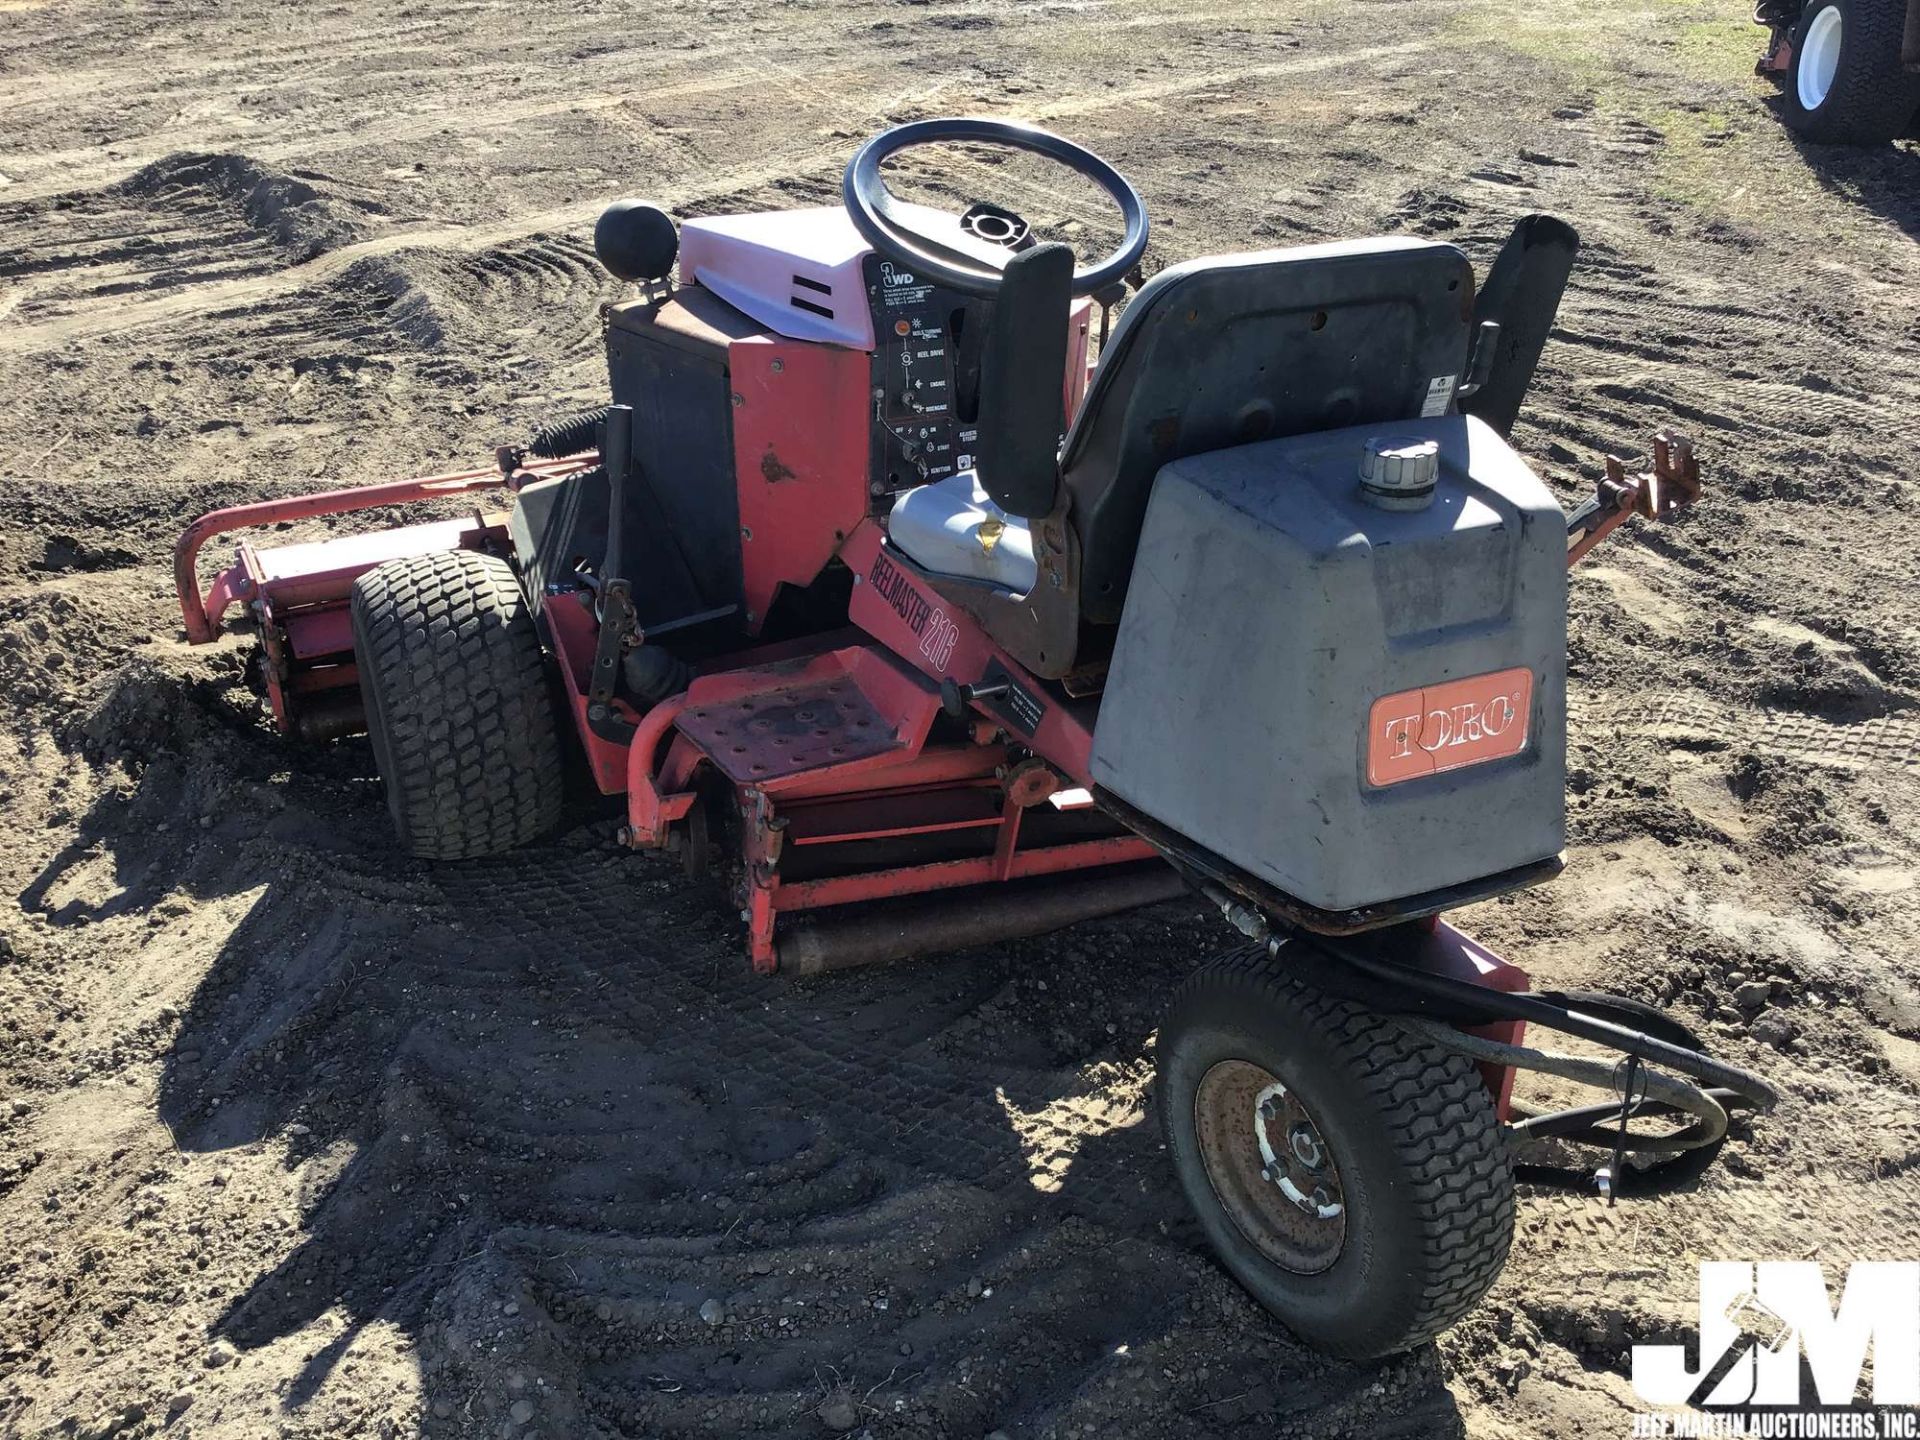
[177,119,1774,1356]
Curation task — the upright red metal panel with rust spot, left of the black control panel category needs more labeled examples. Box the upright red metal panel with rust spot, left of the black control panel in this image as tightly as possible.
[728,334,874,634]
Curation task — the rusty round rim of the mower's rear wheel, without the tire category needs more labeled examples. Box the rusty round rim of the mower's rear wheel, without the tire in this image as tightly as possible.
[1194,1060,1346,1275]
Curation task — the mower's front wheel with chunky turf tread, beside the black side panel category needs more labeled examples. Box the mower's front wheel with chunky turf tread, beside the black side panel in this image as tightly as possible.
[353,549,564,860]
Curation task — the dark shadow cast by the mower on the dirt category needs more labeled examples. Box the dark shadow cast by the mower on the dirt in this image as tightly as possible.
[135,806,1463,1436]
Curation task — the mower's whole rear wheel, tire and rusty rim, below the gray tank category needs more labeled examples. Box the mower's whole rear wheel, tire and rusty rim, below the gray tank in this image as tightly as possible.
[1158,947,1513,1359]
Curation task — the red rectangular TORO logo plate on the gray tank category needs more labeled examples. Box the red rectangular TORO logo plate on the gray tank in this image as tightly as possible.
[1367,666,1534,785]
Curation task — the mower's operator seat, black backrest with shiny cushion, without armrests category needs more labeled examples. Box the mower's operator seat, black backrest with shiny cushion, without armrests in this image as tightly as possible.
[889,238,1473,678]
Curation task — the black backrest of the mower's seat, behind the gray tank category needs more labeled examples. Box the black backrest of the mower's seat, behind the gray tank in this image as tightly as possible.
[1060,240,1473,624]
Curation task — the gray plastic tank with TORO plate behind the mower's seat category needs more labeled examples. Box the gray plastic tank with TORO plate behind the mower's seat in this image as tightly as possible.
[1092,415,1567,910]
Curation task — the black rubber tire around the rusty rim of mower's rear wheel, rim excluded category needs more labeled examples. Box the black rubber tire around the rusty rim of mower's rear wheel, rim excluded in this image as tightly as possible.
[1158,948,1513,1359]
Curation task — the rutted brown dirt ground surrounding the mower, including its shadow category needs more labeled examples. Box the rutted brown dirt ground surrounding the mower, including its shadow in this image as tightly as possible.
[0,0,1920,1440]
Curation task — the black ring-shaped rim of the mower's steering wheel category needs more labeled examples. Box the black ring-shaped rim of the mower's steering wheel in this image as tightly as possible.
[841,119,1146,298]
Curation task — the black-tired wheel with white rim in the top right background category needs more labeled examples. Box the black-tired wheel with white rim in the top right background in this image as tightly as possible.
[1784,0,1920,146]
